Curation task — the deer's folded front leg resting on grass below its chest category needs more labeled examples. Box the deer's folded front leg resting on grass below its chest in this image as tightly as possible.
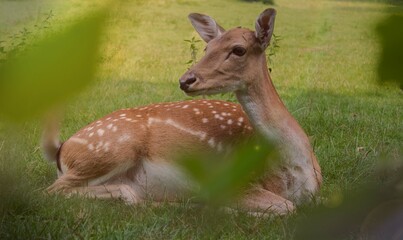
[240,188,295,216]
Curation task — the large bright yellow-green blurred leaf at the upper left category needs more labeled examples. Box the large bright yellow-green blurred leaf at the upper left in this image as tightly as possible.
[0,10,106,120]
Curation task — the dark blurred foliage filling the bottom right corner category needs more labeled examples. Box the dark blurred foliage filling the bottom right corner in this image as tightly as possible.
[295,167,403,240]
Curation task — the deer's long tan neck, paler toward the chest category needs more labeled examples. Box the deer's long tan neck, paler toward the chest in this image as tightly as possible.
[236,59,312,165]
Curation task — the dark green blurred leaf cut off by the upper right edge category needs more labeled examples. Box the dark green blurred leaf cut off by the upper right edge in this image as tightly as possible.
[377,15,403,89]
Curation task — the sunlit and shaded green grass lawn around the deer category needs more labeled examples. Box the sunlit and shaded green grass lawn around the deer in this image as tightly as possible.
[0,0,403,239]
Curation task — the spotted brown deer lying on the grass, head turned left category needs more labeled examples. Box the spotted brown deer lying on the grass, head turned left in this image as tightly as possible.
[41,9,322,215]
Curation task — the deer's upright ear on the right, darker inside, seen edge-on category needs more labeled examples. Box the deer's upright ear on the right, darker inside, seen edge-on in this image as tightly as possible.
[255,8,276,50]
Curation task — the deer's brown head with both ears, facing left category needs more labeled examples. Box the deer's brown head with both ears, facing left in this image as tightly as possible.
[179,8,276,95]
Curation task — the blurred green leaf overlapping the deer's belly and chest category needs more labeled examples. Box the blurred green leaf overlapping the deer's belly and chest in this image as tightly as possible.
[179,137,278,206]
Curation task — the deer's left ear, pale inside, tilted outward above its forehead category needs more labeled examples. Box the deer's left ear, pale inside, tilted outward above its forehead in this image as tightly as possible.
[189,13,225,43]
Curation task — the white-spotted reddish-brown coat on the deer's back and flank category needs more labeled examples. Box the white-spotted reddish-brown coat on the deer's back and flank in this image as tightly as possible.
[44,100,252,192]
